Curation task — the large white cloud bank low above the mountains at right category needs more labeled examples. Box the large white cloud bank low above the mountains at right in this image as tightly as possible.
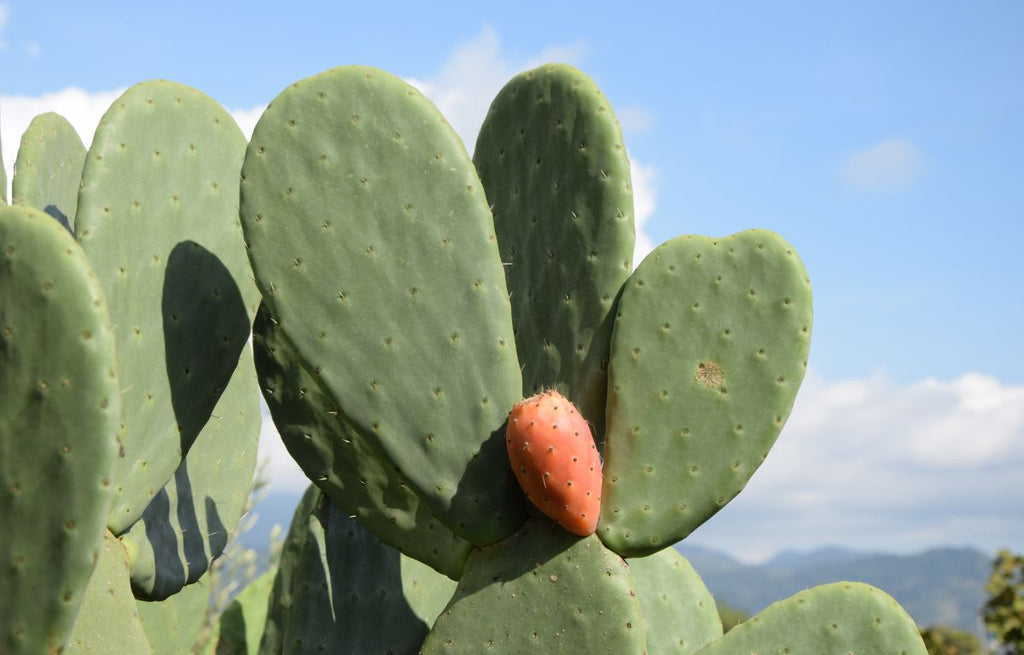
[692,374,1024,561]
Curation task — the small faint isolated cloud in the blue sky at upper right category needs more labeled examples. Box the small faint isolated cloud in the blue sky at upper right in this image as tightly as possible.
[841,138,926,191]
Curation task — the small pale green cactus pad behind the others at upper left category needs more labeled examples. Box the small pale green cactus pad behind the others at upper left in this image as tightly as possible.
[11,112,85,231]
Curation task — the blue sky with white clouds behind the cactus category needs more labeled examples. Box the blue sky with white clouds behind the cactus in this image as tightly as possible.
[0,0,1024,560]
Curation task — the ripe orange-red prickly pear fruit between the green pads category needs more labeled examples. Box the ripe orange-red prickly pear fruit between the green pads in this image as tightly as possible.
[506,390,601,536]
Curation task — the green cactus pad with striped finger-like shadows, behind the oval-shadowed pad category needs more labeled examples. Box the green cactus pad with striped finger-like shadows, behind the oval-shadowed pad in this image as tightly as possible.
[122,348,262,600]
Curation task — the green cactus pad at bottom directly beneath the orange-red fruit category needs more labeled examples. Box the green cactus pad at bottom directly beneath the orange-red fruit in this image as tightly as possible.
[423,519,646,655]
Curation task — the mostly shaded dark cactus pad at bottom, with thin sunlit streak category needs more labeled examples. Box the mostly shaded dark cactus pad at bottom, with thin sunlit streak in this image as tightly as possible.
[283,495,456,655]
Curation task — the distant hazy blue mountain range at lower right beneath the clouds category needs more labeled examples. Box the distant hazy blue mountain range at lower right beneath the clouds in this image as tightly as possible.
[679,545,992,634]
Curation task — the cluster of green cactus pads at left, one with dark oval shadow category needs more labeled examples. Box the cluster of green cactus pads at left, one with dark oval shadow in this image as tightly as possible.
[0,81,260,653]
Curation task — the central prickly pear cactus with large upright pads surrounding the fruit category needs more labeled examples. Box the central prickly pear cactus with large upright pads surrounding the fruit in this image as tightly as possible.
[241,58,929,653]
